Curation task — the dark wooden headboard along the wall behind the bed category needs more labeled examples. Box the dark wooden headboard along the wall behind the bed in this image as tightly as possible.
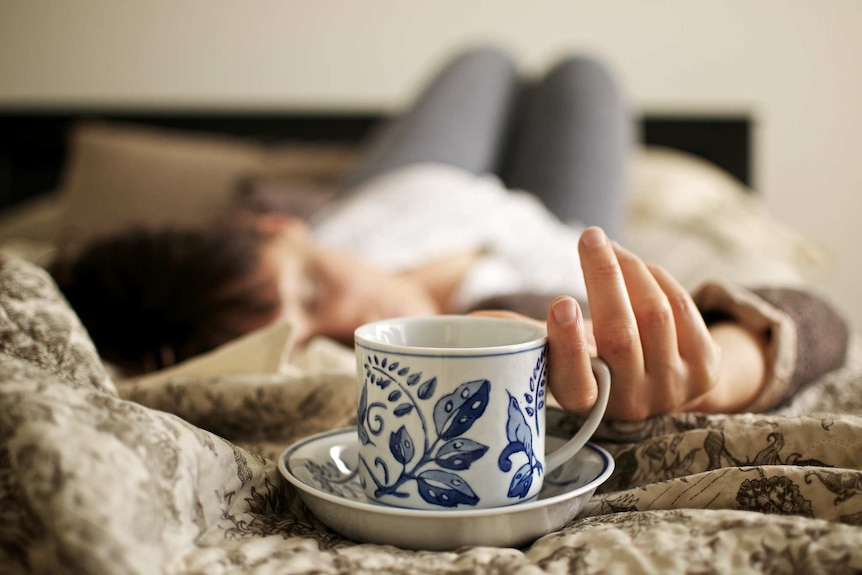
[0,109,752,210]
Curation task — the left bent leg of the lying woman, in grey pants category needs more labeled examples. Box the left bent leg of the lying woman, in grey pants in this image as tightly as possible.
[347,48,518,187]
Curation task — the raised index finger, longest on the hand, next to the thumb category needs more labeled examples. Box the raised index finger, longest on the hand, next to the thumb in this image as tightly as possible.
[578,227,644,380]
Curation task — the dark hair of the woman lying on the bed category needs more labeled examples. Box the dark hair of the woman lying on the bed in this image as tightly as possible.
[50,228,278,373]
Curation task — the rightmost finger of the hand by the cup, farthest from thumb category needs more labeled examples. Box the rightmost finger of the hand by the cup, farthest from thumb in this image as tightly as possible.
[649,265,720,400]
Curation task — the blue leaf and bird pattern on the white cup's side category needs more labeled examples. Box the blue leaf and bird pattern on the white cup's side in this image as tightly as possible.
[357,349,547,507]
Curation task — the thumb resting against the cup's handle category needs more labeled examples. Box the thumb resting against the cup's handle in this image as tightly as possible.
[547,296,598,413]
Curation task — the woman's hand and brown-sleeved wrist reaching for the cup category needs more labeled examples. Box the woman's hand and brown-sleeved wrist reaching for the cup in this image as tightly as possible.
[547,228,847,420]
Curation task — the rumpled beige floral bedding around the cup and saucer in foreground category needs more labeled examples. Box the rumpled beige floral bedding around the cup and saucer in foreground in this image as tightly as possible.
[0,257,862,574]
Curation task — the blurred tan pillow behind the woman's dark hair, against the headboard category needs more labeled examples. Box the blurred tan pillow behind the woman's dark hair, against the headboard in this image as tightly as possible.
[56,122,353,244]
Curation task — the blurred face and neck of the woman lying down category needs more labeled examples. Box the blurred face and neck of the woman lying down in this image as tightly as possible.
[262,219,439,344]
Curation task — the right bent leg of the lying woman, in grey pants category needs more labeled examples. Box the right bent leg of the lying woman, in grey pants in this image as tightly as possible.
[501,57,634,237]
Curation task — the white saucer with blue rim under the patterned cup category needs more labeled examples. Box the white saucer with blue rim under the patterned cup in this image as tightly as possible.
[278,428,614,551]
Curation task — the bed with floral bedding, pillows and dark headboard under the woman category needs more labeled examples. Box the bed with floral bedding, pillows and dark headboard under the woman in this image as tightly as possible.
[0,113,862,574]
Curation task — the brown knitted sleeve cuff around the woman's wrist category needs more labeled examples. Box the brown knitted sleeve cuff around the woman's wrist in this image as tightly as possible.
[694,282,848,412]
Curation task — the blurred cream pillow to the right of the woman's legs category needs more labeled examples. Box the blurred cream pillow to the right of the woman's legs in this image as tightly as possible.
[623,147,829,290]
